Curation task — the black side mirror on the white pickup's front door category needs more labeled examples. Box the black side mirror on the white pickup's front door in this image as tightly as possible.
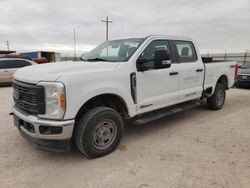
[154,50,172,69]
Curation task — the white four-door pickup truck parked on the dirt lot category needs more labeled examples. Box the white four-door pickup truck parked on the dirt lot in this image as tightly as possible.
[13,36,237,158]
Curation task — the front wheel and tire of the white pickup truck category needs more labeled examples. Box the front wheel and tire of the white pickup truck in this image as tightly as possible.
[74,106,124,158]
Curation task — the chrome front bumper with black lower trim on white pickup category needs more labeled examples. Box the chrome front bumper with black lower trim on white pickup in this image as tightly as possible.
[12,107,75,151]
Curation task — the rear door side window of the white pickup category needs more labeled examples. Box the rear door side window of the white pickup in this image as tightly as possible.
[174,41,198,63]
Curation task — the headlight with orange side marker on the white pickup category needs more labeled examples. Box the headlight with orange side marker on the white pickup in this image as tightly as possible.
[38,82,66,119]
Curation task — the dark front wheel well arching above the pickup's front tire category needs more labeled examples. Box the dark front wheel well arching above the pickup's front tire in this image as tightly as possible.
[76,94,129,121]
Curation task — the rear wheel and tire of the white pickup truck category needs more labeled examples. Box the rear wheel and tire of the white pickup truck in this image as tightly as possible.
[207,83,226,110]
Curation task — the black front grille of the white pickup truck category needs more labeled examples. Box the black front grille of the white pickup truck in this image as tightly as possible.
[12,80,45,115]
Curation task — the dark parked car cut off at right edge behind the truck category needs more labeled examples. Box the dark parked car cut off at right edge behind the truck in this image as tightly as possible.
[235,62,250,87]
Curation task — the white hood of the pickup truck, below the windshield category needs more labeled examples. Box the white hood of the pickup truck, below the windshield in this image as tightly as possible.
[14,61,120,83]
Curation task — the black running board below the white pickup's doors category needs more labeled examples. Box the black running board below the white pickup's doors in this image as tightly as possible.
[134,101,201,125]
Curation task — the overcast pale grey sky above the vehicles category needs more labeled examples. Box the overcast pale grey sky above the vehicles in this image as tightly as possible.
[0,0,250,56]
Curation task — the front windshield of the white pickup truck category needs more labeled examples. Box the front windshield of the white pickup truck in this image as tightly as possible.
[82,38,144,62]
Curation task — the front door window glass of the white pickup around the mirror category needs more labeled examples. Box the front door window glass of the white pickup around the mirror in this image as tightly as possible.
[139,40,171,69]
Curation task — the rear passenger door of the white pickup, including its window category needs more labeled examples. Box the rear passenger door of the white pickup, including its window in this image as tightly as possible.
[172,40,204,102]
